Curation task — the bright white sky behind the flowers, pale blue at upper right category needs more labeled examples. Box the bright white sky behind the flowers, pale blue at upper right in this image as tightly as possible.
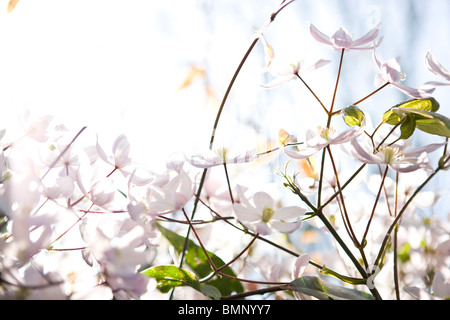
[0,0,450,190]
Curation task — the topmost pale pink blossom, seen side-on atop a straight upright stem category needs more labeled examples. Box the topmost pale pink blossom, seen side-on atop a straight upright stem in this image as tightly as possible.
[309,23,381,51]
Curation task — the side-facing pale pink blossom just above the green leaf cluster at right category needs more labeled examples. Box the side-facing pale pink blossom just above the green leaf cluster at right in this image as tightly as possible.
[373,50,435,99]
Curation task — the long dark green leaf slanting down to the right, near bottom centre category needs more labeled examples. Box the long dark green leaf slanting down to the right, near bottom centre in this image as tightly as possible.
[156,224,244,296]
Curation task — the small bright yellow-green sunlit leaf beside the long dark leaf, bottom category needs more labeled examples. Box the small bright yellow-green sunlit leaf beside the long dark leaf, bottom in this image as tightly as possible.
[141,266,201,293]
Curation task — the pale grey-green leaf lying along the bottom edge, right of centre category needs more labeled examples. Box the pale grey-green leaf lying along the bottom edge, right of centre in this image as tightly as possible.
[291,276,373,300]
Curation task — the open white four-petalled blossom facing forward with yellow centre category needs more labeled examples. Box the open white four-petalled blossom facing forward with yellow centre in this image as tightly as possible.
[233,189,306,235]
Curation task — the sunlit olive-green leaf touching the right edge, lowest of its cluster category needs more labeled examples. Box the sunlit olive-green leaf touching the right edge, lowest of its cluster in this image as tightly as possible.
[391,108,450,137]
